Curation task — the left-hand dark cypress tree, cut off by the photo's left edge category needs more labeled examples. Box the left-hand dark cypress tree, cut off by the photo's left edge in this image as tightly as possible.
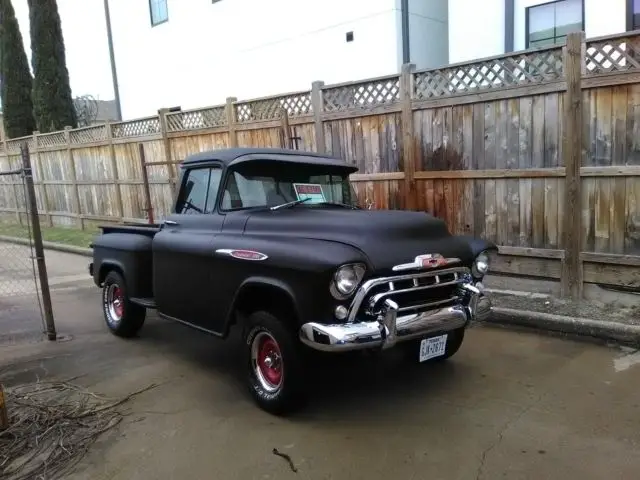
[0,0,36,138]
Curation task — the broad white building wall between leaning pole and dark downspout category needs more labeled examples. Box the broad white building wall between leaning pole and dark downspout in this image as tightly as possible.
[111,0,401,118]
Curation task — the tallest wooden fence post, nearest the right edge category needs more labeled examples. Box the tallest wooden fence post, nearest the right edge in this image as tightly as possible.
[561,32,585,300]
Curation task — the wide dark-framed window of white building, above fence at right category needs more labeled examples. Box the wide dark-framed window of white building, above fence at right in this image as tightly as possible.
[526,0,584,48]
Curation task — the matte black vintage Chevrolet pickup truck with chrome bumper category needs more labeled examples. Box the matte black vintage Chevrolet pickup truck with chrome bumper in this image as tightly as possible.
[89,148,496,414]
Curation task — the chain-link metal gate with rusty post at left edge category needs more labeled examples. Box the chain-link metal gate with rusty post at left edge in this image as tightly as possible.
[0,143,56,345]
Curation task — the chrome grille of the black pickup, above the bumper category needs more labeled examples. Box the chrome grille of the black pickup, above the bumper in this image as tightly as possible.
[348,267,470,322]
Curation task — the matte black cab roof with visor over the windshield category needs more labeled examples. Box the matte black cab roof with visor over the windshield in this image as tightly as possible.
[182,147,358,173]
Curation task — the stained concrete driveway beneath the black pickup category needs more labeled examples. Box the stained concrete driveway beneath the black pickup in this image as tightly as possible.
[0,248,640,480]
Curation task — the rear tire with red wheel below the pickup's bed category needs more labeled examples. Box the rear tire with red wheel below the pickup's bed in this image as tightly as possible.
[102,270,147,338]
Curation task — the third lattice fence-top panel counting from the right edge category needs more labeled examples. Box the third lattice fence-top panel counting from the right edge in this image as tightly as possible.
[322,75,400,112]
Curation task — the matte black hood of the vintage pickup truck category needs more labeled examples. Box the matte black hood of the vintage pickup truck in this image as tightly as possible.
[245,206,473,274]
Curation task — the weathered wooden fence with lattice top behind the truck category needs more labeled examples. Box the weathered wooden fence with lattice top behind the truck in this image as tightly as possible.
[0,32,640,297]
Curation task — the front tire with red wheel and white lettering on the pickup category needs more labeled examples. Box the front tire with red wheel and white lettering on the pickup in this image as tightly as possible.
[243,311,306,415]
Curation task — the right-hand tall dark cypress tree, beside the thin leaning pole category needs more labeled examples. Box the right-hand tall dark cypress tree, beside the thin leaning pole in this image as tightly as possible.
[29,0,77,133]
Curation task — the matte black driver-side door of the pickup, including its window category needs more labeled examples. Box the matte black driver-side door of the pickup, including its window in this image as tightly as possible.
[153,164,224,328]
